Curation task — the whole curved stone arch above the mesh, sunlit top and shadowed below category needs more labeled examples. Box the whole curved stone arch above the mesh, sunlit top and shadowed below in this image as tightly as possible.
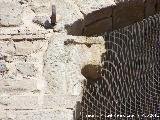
[54,0,160,36]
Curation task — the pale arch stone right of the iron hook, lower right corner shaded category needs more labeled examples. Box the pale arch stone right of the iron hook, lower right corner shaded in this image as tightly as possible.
[54,0,83,35]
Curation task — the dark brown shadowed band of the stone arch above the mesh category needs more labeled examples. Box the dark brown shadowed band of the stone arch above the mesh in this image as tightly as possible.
[65,0,160,37]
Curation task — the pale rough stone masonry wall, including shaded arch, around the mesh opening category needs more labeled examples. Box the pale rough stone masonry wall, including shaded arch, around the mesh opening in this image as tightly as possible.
[0,0,160,120]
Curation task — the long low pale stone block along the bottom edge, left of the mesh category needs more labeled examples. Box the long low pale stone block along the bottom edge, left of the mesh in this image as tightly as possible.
[6,109,74,120]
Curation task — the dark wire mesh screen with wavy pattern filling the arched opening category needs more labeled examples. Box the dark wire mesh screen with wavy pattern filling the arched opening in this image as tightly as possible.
[79,14,160,120]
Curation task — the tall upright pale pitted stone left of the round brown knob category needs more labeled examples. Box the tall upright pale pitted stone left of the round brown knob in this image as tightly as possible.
[44,34,83,94]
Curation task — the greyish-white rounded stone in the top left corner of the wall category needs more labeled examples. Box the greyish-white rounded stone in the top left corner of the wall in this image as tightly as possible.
[0,1,23,27]
